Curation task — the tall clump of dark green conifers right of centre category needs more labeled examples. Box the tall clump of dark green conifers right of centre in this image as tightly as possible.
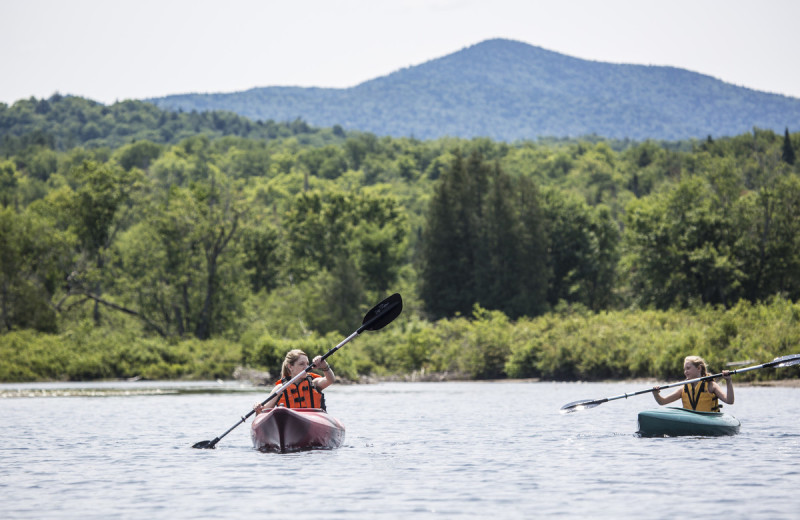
[421,149,548,319]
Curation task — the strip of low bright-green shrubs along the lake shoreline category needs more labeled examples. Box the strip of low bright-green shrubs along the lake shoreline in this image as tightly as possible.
[0,298,800,383]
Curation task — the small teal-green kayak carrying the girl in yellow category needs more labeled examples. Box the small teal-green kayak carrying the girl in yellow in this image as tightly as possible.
[638,407,741,437]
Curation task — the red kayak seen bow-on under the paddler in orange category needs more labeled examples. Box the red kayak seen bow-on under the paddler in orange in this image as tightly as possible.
[250,406,344,453]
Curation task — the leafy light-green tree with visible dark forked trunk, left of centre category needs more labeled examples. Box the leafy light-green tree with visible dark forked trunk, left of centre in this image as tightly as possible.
[114,177,247,339]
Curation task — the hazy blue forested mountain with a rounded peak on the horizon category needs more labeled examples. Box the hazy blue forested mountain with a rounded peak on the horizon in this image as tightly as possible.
[145,39,800,142]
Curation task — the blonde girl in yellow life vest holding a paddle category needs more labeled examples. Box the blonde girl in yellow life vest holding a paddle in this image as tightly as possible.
[653,356,733,412]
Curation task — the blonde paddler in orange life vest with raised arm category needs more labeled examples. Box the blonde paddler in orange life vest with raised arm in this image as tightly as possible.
[254,349,336,414]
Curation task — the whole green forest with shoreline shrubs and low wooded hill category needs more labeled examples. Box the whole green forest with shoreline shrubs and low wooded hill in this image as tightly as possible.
[0,95,800,381]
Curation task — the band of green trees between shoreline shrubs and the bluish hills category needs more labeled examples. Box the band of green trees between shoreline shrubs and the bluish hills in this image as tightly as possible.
[0,98,800,377]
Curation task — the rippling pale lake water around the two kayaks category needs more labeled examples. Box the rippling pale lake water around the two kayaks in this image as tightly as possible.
[0,382,800,520]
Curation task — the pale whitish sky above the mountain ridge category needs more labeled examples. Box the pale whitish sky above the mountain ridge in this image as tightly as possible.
[0,0,800,104]
